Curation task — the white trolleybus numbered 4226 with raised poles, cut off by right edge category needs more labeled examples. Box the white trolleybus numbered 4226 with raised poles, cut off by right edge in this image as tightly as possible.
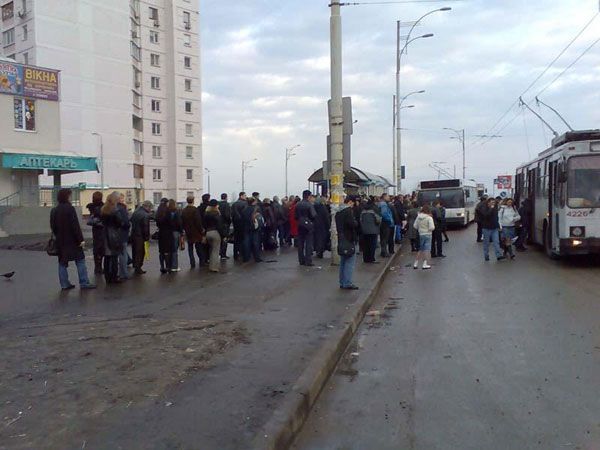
[515,130,600,257]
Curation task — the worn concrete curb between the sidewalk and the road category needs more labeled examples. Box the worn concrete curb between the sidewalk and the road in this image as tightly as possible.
[252,247,401,450]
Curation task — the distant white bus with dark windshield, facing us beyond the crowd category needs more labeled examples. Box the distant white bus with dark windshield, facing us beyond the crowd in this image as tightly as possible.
[417,180,478,226]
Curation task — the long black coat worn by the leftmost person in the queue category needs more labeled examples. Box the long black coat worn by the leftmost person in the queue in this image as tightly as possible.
[50,203,85,265]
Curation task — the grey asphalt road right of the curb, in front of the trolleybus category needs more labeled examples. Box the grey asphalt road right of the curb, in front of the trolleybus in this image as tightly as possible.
[294,228,600,450]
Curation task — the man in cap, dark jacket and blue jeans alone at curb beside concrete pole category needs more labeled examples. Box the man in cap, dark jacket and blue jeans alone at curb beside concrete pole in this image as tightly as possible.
[335,195,358,290]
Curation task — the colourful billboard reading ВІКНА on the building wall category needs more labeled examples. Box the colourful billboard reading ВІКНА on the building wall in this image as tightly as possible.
[0,61,59,101]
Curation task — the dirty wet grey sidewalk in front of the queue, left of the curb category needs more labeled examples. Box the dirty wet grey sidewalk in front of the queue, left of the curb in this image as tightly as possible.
[0,246,404,450]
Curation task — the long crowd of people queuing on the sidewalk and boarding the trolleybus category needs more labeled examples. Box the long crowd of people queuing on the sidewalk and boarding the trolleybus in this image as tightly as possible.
[50,189,530,290]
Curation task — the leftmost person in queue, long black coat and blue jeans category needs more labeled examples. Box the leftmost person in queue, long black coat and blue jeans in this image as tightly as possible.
[50,189,96,291]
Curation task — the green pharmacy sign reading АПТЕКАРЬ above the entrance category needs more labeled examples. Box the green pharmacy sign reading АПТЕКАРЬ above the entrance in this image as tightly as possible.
[2,153,98,172]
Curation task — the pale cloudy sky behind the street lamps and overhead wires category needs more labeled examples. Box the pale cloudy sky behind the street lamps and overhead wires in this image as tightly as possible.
[200,0,600,196]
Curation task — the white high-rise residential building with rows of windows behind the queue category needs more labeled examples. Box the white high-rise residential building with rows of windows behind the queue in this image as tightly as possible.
[0,0,203,203]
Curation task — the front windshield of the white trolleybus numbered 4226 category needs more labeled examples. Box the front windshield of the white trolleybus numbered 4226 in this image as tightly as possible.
[567,155,600,208]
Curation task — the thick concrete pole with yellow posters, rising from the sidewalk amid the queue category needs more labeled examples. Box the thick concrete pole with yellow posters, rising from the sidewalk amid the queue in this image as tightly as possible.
[329,0,344,265]
